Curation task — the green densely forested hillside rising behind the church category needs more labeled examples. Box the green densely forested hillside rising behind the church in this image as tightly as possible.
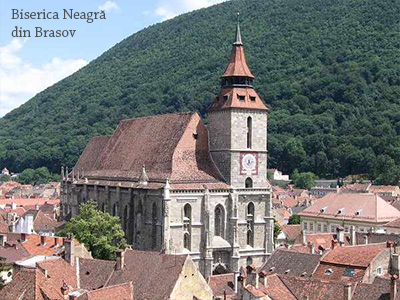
[0,0,400,182]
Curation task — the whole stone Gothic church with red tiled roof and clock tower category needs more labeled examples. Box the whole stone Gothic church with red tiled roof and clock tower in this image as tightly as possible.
[61,19,274,278]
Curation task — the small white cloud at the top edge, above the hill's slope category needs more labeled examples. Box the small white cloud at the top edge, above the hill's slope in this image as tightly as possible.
[154,0,225,21]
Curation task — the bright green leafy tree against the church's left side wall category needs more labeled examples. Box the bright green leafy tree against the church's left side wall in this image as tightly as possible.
[58,200,126,260]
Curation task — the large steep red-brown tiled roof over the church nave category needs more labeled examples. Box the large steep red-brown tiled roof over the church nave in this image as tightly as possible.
[75,113,223,184]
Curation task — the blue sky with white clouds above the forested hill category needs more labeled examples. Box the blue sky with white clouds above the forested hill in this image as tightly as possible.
[0,0,224,117]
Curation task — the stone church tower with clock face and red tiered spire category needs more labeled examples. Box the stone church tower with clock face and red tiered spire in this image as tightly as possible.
[208,16,268,189]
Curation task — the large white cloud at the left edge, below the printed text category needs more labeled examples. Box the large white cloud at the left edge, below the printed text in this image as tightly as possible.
[0,38,87,117]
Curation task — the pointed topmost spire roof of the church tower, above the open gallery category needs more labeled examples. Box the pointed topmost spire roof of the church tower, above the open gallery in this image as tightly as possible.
[221,13,254,78]
